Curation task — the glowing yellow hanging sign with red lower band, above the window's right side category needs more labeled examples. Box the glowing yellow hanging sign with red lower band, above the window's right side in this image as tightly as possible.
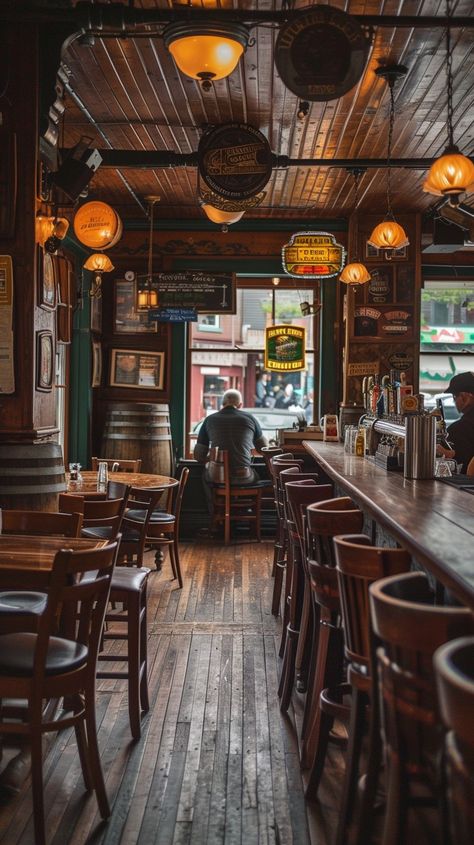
[282,232,346,279]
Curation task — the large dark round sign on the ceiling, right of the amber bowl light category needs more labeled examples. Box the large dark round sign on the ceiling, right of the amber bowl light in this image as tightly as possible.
[275,6,372,102]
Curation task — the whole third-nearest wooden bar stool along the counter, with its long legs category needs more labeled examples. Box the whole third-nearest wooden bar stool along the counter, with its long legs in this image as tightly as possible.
[334,534,411,845]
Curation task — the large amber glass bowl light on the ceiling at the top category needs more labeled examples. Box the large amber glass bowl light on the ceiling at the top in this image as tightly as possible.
[163,21,250,91]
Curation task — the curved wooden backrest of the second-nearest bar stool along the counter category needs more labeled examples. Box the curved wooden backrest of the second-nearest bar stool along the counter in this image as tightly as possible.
[369,572,474,782]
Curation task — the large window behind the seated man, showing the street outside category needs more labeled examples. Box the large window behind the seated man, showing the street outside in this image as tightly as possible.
[188,280,317,454]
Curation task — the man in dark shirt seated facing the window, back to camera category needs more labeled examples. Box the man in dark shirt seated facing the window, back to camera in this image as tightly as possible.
[194,390,268,513]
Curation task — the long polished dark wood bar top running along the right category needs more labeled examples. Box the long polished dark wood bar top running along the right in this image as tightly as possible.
[304,440,474,609]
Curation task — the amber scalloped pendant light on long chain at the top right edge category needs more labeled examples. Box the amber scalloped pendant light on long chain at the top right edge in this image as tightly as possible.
[423,0,474,205]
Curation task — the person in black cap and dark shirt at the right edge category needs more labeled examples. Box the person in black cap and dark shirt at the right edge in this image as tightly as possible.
[437,373,474,473]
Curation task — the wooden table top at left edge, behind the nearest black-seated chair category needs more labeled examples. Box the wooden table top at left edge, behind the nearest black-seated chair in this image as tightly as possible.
[0,534,107,572]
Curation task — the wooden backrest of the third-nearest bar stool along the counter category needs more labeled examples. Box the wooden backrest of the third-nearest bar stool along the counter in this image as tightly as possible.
[334,534,411,672]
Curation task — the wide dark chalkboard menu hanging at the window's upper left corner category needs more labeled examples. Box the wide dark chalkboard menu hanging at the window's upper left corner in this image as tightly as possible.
[138,270,235,314]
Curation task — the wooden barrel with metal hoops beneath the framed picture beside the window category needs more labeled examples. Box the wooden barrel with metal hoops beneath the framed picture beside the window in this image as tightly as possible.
[101,402,174,475]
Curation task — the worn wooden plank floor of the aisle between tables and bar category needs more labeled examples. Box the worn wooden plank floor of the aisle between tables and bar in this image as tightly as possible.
[0,541,342,845]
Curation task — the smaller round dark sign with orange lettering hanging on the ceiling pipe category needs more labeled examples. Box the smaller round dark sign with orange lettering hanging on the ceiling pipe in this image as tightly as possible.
[198,123,272,201]
